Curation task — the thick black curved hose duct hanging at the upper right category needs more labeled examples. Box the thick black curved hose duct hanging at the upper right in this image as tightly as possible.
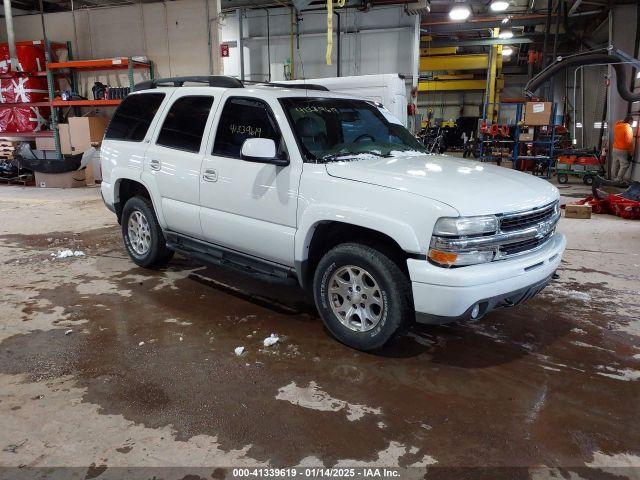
[524,49,640,102]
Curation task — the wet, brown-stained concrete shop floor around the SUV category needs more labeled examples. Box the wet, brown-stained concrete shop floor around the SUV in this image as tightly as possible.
[0,182,640,480]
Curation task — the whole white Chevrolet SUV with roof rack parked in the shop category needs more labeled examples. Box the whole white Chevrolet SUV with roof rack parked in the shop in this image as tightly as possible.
[102,77,566,350]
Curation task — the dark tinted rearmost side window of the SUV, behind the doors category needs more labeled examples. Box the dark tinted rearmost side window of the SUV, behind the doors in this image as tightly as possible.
[105,93,164,142]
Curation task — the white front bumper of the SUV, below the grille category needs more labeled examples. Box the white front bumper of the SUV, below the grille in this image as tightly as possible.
[407,233,566,324]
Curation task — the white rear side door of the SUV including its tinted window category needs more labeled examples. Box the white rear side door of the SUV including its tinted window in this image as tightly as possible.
[145,89,214,238]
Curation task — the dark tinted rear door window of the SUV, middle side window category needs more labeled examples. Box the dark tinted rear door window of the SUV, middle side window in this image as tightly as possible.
[156,96,213,153]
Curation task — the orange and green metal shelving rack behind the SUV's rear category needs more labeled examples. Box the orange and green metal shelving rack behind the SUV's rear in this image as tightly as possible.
[47,57,154,158]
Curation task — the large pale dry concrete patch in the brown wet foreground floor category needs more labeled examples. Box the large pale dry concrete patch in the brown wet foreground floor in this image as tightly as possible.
[276,381,382,422]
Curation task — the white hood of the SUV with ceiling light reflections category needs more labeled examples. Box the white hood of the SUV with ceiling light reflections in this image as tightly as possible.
[326,153,559,216]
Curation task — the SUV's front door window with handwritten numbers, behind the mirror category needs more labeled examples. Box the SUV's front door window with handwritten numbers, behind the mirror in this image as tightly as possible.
[213,98,284,158]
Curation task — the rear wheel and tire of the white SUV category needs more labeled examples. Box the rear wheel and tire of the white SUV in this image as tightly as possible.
[121,196,174,268]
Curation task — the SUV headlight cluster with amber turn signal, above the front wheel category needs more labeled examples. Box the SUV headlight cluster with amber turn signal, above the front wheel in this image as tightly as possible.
[428,215,498,267]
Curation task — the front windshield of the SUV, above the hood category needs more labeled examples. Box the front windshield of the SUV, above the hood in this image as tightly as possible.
[280,97,426,162]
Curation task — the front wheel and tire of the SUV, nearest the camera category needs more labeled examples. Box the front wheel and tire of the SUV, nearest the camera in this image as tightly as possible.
[313,243,415,351]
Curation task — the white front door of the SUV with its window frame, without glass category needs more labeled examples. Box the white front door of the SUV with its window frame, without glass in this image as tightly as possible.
[200,89,302,266]
